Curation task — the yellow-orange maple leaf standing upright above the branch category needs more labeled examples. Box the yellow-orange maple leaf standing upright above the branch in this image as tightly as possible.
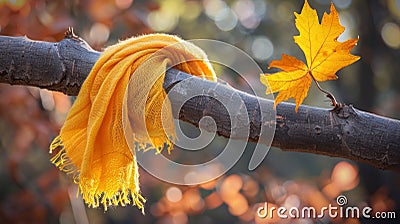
[260,0,360,112]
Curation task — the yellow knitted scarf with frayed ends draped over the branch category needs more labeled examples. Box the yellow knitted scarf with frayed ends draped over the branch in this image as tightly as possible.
[50,34,216,211]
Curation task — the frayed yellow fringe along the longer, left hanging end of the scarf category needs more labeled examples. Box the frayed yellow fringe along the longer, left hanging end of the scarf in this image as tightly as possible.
[49,136,146,214]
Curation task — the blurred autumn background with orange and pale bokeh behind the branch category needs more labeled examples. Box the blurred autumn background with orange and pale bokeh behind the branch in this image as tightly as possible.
[0,0,400,224]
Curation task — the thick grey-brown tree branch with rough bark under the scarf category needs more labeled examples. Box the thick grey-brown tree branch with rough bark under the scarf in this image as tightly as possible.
[0,33,400,170]
